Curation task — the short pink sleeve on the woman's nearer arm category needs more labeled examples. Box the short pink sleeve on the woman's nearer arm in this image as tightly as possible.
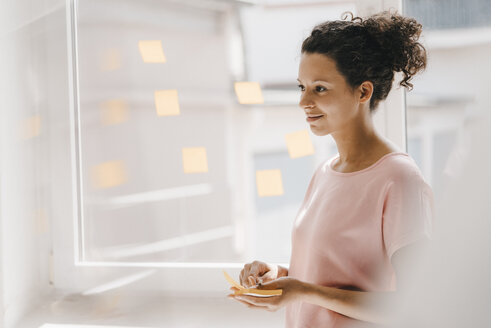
[382,170,434,259]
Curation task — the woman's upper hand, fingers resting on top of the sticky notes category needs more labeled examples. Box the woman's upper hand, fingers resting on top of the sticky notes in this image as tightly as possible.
[239,261,288,287]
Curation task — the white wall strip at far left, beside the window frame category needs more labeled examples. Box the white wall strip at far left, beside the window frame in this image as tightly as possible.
[0,0,68,327]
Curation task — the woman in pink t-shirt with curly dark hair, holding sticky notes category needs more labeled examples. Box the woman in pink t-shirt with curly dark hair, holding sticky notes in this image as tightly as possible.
[230,12,433,327]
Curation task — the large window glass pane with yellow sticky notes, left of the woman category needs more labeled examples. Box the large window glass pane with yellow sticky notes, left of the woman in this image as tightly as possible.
[77,0,376,263]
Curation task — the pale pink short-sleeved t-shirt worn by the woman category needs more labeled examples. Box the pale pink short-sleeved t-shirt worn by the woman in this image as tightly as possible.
[286,152,434,328]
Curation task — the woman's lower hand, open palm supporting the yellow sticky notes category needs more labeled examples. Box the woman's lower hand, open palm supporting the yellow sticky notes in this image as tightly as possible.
[228,277,306,312]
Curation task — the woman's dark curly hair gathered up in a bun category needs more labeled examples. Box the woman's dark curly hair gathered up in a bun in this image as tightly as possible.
[301,11,427,112]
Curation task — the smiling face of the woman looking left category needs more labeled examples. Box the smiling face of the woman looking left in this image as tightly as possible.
[298,53,359,136]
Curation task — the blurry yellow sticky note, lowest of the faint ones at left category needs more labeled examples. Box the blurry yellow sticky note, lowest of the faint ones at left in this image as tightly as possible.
[91,161,128,188]
